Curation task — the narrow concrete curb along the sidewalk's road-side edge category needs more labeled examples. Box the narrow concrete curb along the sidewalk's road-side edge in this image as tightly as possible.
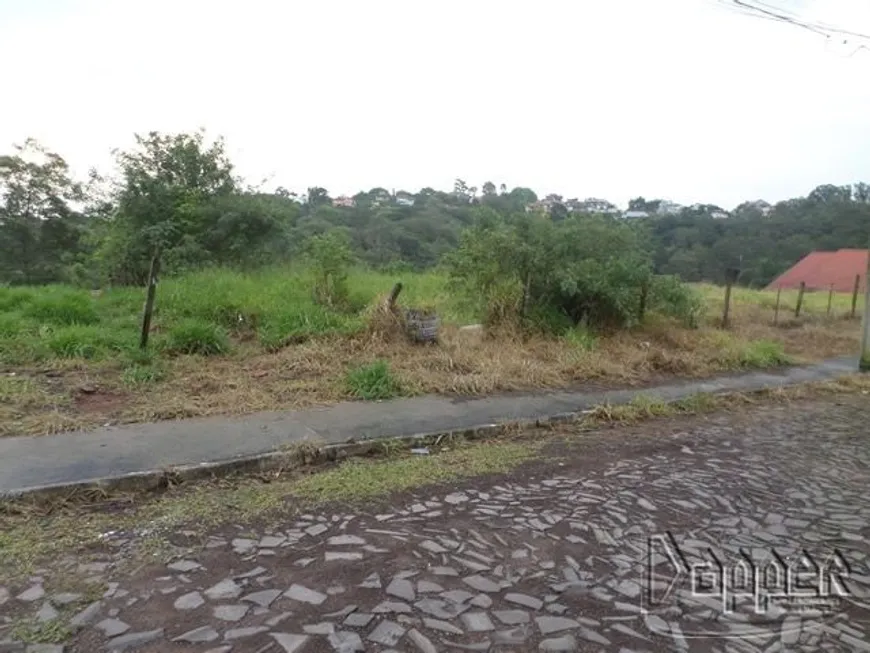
[0,366,850,501]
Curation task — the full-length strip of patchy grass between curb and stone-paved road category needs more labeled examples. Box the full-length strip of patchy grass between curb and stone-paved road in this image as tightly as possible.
[0,374,870,579]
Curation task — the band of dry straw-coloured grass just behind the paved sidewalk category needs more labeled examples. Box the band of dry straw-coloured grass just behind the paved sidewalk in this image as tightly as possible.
[0,288,859,435]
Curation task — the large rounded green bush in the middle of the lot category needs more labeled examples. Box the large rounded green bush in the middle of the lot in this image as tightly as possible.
[445,209,664,330]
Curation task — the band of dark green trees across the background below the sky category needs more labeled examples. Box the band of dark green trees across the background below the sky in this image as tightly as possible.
[0,132,870,288]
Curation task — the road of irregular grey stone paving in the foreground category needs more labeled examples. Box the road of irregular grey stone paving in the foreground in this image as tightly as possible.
[0,397,870,653]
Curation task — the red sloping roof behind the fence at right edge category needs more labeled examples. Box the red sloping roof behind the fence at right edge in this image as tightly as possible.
[767,249,867,293]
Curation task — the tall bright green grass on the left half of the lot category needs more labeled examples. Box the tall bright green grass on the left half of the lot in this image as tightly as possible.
[0,267,477,365]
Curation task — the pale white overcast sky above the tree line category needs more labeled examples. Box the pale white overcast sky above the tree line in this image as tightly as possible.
[0,0,870,208]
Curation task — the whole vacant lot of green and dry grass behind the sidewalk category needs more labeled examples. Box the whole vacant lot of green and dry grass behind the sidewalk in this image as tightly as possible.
[0,269,860,435]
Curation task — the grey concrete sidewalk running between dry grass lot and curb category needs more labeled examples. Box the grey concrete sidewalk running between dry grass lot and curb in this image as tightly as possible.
[0,358,858,494]
